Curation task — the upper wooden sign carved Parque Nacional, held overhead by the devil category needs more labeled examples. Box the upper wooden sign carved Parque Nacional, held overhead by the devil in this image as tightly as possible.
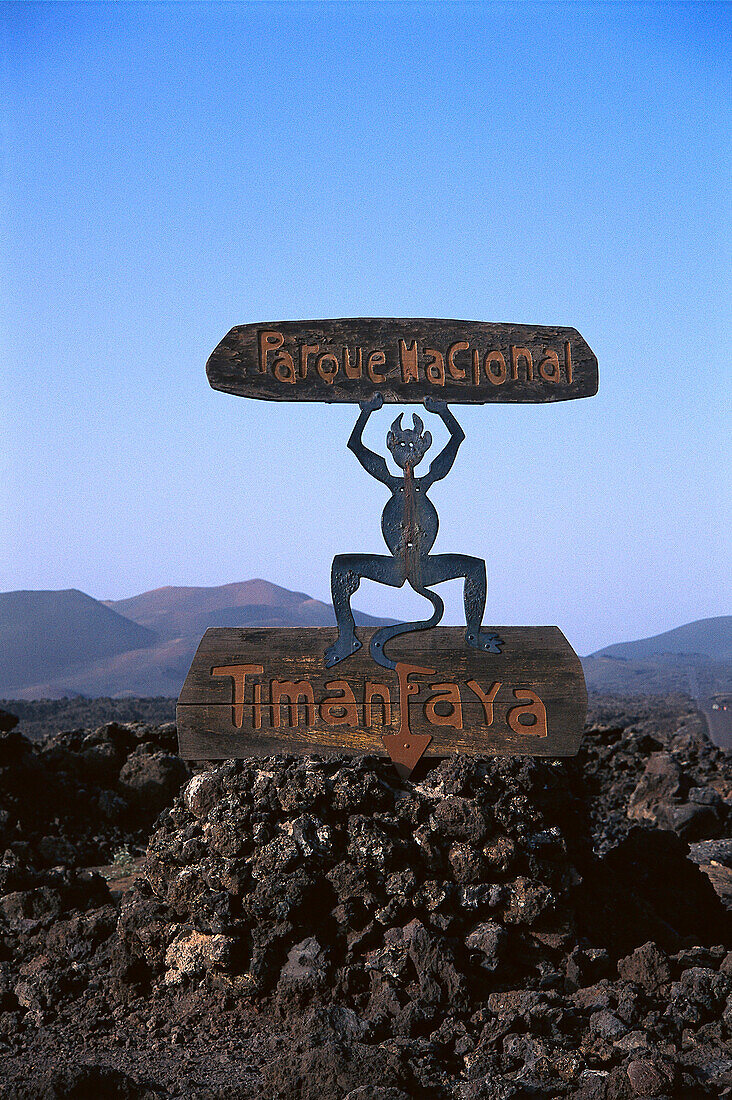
[206,317,598,405]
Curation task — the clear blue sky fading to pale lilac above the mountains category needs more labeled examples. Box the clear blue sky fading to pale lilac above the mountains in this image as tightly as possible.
[0,2,732,653]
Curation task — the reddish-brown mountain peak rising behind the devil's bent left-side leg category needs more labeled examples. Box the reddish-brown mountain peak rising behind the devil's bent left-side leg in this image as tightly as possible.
[105,580,392,639]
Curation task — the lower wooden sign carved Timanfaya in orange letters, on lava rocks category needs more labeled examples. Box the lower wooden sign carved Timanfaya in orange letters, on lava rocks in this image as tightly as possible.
[176,626,587,774]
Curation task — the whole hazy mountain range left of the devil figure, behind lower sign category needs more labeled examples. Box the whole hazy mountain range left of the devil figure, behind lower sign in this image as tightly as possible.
[0,580,393,699]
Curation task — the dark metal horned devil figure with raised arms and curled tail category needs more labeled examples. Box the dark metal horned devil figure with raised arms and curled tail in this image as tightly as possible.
[325,393,503,669]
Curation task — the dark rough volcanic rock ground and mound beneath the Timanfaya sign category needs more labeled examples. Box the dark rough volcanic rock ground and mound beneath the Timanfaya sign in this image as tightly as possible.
[0,697,732,1100]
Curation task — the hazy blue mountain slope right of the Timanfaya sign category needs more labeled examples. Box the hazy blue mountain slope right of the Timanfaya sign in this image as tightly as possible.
[582,615,732,699]
